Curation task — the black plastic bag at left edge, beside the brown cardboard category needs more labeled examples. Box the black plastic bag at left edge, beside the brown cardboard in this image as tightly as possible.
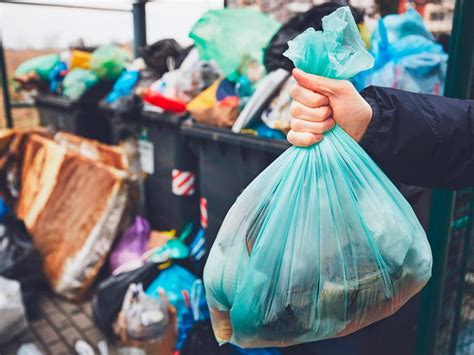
[0,215,44,317]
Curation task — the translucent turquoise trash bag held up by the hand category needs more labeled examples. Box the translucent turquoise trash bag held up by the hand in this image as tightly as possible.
[204,7,432,348]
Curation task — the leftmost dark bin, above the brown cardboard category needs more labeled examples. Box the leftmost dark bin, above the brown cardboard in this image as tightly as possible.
[35,82,112,143]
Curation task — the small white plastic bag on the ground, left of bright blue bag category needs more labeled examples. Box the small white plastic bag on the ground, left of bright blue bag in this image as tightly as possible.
[122,283,171,341]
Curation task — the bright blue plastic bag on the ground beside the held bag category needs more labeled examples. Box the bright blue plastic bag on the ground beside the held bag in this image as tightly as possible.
[146,265,209,350]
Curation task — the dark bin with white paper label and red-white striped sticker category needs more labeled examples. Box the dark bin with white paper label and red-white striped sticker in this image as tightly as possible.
[138,110,199,231]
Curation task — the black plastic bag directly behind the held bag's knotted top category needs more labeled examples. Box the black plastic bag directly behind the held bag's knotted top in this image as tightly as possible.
[263,2,364,73]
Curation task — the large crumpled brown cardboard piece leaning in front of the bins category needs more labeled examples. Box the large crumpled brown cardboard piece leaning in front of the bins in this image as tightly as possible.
[1,132,135,299]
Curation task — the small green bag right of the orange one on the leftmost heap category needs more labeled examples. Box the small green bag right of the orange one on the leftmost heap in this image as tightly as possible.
[90,45,130,80]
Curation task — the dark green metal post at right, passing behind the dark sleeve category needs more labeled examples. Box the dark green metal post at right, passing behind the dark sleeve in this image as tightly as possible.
[415,0,474,355]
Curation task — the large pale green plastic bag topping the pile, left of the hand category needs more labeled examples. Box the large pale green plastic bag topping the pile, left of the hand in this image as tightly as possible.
[189,9,280,76]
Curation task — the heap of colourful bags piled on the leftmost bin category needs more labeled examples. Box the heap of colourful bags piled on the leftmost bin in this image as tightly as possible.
[14,45,130,101]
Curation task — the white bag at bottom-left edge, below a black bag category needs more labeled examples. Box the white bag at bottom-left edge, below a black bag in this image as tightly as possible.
[0,276,27,344]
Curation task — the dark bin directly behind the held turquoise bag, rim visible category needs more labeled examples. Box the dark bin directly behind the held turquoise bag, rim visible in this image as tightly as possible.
[181,120,290,248]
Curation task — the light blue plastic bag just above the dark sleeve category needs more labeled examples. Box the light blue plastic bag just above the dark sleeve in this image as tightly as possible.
[359,9,448,95]
